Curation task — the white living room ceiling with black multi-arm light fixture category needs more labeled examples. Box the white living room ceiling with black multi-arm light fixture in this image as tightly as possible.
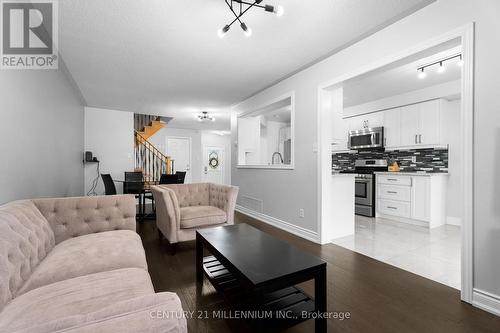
[59,0,433,129]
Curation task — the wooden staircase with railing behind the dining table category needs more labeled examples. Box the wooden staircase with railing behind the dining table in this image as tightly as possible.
[134,114,174,183]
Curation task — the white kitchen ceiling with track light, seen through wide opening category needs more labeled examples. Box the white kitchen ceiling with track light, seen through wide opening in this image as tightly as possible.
[343,39,461,107]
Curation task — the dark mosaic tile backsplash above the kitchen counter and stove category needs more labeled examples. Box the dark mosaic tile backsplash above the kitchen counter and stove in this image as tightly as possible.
[332,148,448,172]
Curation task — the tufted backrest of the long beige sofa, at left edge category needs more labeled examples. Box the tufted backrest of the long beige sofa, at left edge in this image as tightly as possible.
[0,201,55,310]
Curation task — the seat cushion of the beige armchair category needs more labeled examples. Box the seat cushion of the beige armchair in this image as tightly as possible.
[181,206,227,229]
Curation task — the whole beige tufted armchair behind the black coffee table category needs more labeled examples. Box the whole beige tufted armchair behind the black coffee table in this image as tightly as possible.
[151,183,239,250]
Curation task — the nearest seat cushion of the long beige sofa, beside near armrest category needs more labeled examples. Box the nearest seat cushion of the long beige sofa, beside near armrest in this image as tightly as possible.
[0,268,154,332]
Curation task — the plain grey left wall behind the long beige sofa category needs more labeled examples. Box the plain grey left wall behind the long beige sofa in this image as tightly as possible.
[0,69,83,204]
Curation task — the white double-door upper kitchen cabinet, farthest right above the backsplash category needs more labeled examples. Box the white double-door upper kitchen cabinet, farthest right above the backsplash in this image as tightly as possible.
[400,100,442,147]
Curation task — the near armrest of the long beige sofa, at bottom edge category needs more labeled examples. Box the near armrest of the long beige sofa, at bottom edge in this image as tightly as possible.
[18,292,187,333]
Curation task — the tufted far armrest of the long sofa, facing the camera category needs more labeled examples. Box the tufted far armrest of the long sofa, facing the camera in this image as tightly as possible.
[33,195,136,244]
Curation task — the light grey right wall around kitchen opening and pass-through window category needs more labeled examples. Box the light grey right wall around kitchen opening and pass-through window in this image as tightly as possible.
[231,0,500,303]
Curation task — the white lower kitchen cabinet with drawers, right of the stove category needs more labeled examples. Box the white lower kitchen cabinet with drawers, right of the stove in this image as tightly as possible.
[376,173,447,228]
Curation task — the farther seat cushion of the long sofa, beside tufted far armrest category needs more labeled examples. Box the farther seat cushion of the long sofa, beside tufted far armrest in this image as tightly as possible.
[19,230,147,294]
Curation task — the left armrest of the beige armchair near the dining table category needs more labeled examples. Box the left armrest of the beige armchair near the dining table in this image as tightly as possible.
[151,185,181,243]
